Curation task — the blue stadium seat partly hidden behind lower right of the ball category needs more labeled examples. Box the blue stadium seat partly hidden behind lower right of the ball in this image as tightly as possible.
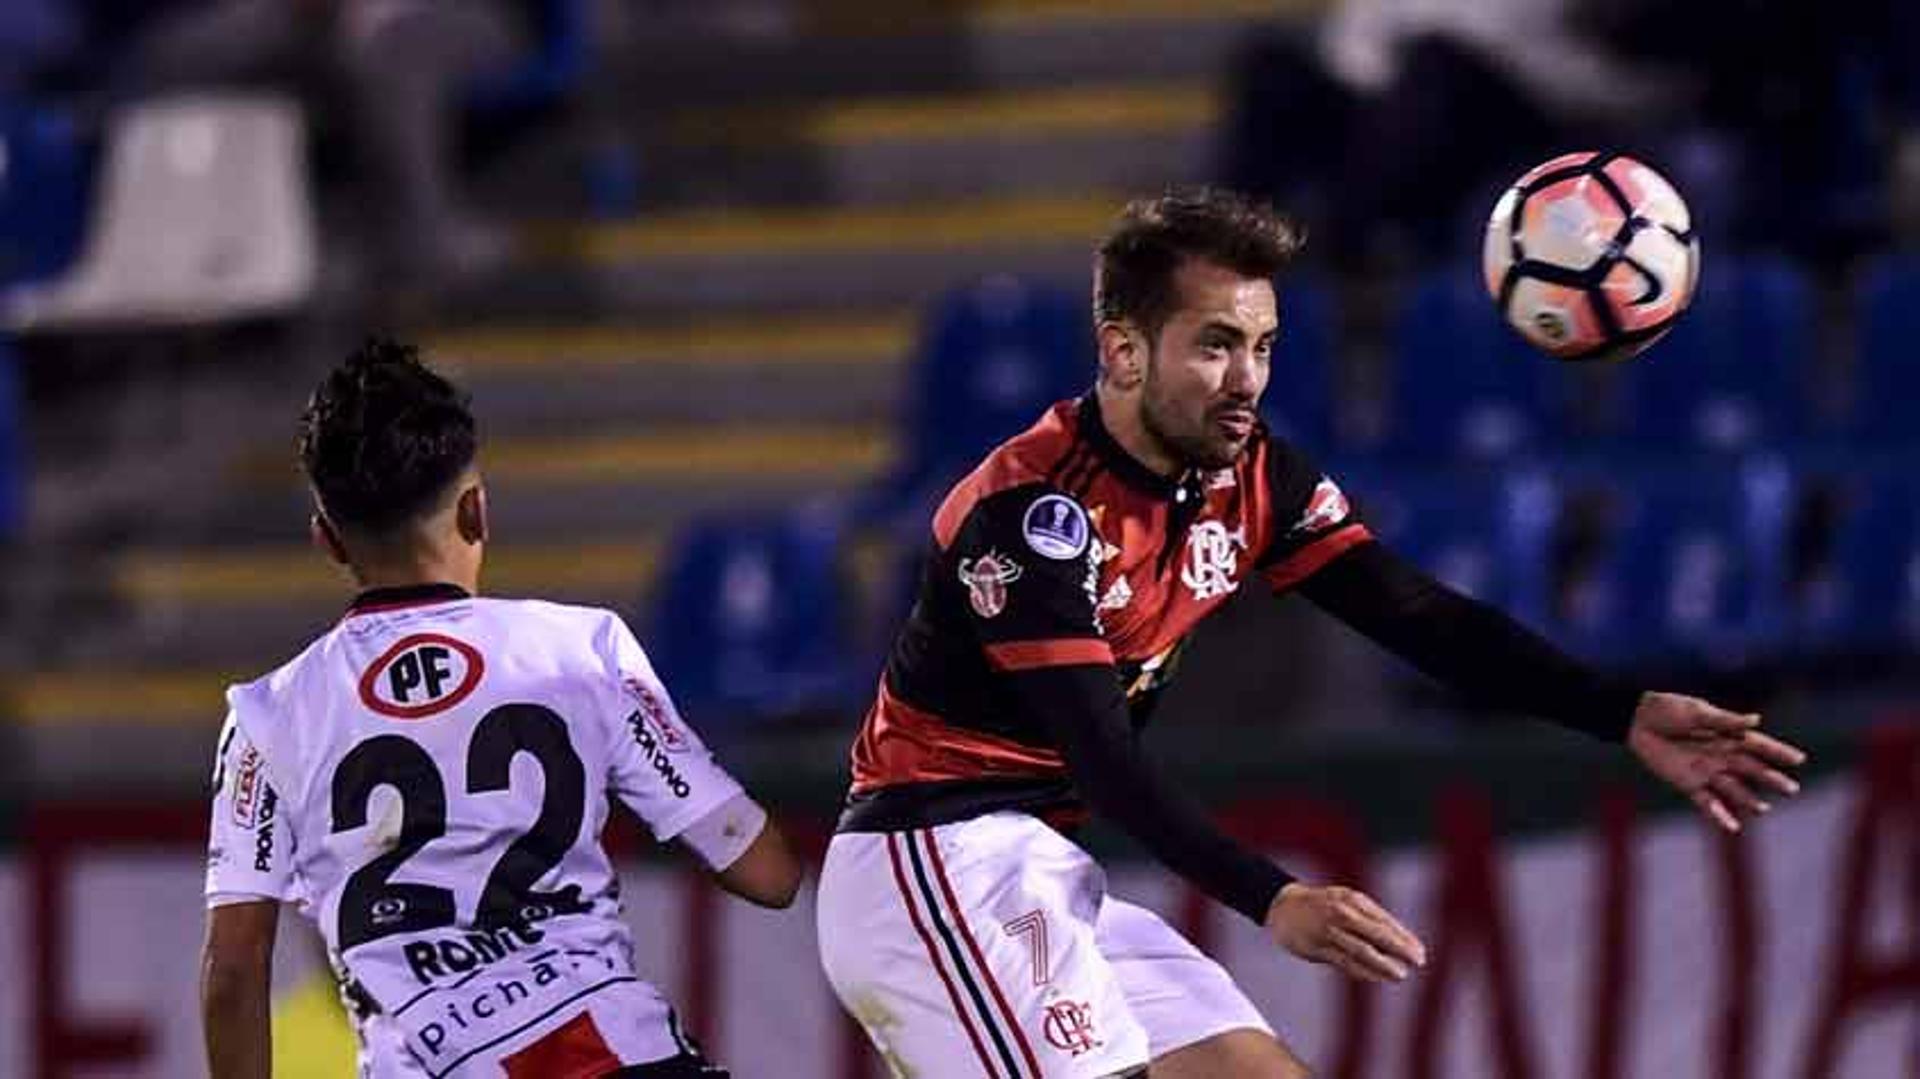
[1620,259,1816,453]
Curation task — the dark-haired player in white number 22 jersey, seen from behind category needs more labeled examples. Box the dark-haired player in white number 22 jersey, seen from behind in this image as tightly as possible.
[202,342,801,1079]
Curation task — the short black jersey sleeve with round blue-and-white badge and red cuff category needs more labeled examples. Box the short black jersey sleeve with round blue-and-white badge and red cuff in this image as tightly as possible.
[956,484,1114,672]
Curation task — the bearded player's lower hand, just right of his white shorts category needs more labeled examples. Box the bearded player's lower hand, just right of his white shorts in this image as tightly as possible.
[1267,881,1427,981]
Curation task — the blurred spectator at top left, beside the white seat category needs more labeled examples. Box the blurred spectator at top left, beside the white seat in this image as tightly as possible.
[132,0,532,284]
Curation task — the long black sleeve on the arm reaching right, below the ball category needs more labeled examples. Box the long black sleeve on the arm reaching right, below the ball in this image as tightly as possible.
[1300,541,1640,741]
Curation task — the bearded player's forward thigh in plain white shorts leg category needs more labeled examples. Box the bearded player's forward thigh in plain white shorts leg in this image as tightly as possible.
[1096,899,1306,1079]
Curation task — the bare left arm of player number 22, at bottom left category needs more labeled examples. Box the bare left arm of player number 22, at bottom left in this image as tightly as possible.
[200,900,280,1079]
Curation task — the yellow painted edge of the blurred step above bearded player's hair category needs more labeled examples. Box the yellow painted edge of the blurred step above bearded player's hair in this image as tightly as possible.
[672,83,1221,146]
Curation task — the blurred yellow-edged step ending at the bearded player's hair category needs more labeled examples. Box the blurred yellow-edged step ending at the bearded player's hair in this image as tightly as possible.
[483,192,1137,321]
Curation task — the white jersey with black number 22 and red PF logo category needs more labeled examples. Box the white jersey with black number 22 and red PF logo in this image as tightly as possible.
[207,586,748,1079]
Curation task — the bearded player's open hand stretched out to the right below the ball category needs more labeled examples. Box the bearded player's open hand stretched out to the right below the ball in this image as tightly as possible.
[1626,693,1807,831]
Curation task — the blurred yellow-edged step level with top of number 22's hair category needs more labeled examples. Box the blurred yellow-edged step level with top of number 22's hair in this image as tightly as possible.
[426,309,920,426]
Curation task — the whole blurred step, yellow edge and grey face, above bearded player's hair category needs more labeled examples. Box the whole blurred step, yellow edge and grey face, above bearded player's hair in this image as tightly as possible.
[647,81,1221,205]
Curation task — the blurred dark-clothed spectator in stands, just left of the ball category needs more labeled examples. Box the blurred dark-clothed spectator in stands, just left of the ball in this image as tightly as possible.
[1225,0,1684,259]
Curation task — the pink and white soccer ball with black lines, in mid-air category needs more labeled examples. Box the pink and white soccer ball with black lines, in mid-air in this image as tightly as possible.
[1480,154,1699,361]
